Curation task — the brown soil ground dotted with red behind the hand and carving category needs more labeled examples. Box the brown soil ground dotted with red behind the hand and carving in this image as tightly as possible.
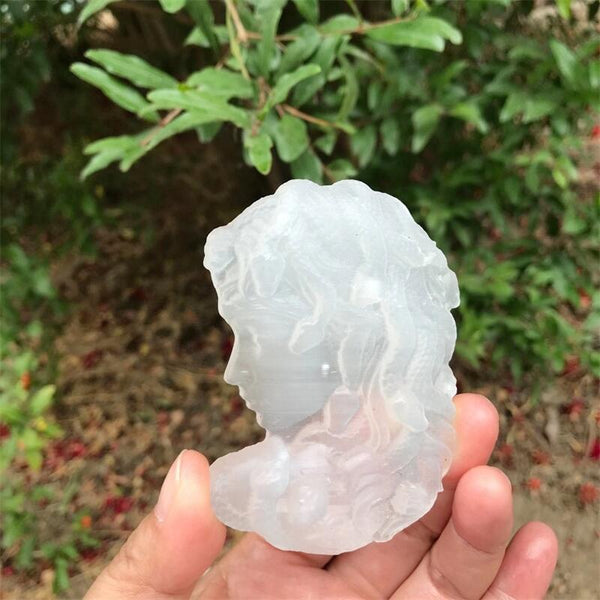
[2,134,600,600]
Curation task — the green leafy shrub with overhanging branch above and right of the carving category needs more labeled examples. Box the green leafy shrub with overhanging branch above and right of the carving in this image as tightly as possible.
[71,0,600,379]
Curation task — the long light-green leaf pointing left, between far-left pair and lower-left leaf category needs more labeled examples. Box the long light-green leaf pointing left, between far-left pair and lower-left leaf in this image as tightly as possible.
[148,90,250,128]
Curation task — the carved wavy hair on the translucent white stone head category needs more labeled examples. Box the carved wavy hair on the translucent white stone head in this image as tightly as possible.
[204,180,459,431]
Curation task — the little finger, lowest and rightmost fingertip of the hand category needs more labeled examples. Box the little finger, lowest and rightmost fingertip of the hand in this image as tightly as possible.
[483,523,558,600]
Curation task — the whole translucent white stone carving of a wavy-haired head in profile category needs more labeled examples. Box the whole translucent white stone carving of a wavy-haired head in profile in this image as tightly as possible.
[204,180,459,554]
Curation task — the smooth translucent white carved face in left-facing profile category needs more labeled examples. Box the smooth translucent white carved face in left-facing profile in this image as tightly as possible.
[224,301,340,433]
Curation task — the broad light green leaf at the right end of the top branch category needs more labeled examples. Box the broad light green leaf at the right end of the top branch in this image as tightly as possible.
[366,16,462,52]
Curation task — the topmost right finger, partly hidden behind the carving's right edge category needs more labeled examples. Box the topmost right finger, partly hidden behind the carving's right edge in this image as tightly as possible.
[327,394,498,597]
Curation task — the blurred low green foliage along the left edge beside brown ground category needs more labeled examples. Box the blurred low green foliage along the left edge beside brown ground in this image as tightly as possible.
[0,146,103,594]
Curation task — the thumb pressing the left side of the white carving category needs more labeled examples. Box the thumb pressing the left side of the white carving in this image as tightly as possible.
[84,450,225,600]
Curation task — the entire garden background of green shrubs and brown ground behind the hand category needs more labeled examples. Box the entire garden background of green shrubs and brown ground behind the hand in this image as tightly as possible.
[0,0,600,598]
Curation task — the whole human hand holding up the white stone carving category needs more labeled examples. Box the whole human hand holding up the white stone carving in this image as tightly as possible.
[85,394,557,600]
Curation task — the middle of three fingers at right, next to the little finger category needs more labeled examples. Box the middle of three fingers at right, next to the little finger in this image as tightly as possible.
[392,467,513,600]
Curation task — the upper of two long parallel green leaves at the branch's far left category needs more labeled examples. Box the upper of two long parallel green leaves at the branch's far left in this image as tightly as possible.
[85,50,178,88]
